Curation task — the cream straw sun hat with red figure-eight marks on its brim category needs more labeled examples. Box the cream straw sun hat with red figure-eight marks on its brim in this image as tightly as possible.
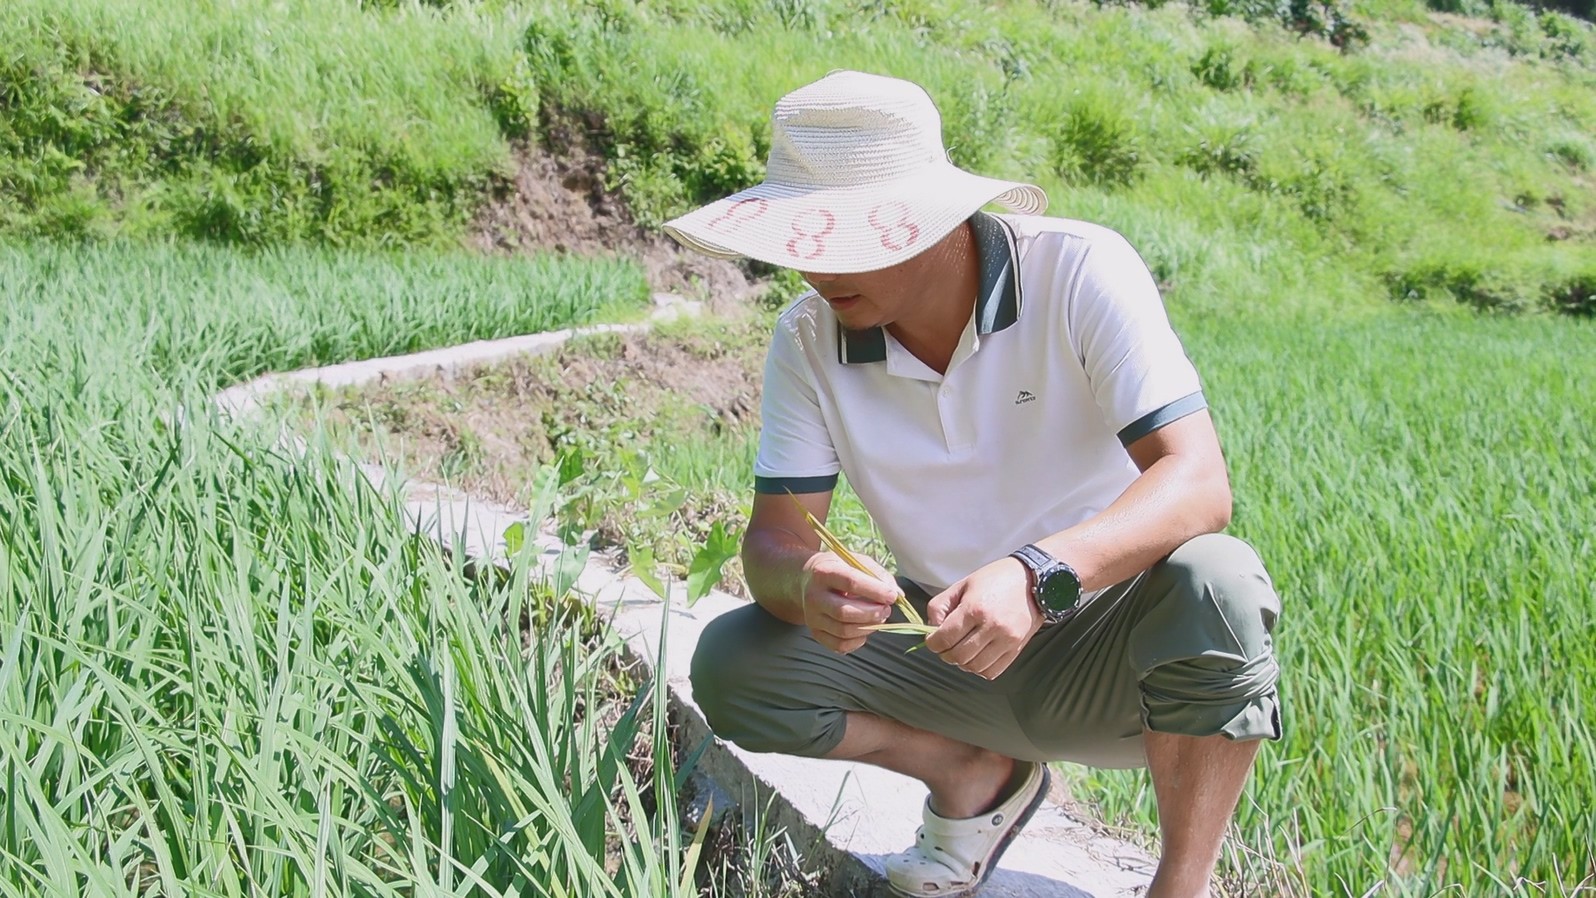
[666,72,1047,274]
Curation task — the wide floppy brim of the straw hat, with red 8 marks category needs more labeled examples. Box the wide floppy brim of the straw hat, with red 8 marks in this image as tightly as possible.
[664,164,1047,274]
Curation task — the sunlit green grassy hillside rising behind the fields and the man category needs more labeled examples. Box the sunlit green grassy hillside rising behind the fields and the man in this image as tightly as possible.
[0,0,1596,311]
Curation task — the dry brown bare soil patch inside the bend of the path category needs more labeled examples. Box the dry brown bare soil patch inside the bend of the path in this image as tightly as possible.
[321,316,764,504]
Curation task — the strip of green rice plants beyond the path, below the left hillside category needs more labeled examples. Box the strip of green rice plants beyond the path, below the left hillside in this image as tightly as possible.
[0,244,648,388]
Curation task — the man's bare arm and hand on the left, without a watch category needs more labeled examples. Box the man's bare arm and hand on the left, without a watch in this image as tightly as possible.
[742,493,897,652]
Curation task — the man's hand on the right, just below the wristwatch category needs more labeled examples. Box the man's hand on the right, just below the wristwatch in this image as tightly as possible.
[926,558,1042,679]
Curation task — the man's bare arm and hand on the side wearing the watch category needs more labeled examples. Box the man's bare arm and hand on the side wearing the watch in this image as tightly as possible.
[926,410,1231,679]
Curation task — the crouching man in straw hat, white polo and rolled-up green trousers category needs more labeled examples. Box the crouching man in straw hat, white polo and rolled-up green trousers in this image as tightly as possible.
[667,72,1280,898]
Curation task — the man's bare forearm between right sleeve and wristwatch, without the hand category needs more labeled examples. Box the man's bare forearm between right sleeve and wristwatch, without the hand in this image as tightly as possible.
[1037,456,1231,590]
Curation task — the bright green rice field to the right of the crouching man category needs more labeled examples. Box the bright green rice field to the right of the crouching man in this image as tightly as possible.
[1087,307,1596,895]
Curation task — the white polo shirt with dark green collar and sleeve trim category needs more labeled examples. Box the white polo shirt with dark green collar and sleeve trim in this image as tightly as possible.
[753,214,1207,593]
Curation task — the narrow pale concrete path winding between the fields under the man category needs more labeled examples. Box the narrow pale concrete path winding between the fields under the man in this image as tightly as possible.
[215,300,1152,898]
